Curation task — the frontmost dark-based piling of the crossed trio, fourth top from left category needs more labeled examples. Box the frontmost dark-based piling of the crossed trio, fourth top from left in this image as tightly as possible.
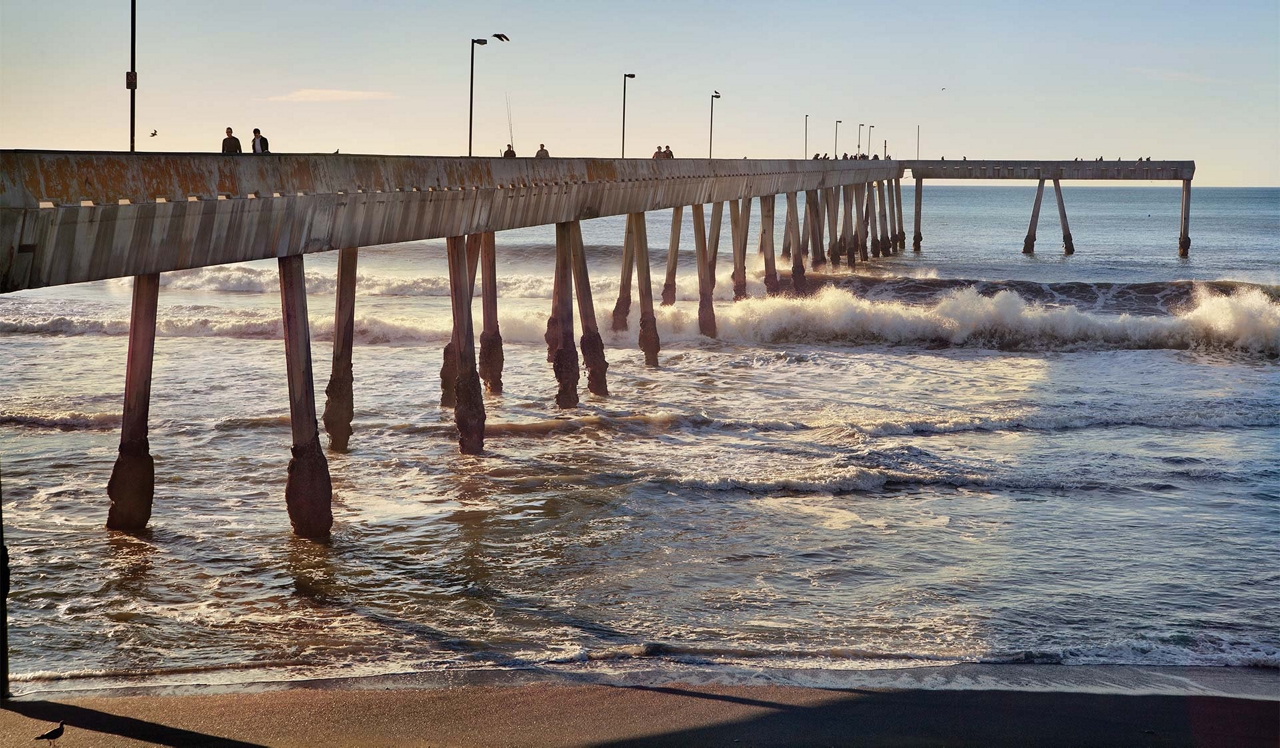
[444,234,485,455]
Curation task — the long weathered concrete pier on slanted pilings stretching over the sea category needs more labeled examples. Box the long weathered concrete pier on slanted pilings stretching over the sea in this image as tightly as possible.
[0,151,1194,538]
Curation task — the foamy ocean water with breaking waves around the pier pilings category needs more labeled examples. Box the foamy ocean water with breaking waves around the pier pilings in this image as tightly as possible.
[0,183,1280,694]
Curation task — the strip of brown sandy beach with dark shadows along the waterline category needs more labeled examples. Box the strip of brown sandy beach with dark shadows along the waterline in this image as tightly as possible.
[0,672,1280,748]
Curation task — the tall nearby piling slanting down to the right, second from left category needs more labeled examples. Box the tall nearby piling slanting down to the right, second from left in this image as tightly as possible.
[279,255,333,539]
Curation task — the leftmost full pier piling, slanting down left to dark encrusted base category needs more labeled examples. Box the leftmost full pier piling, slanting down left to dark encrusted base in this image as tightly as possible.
[106,273,160,532]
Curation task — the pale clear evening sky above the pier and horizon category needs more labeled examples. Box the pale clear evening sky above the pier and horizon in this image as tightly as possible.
[0,0,1280,186]
